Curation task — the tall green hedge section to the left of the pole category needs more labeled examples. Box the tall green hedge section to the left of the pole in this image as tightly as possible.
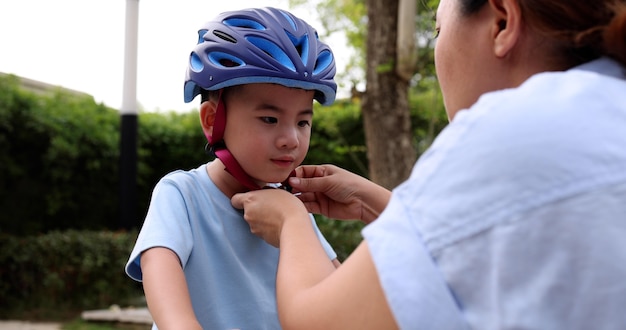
[0,76,119,234]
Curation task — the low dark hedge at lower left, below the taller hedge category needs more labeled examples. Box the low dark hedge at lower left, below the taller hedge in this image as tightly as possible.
[0,230,143,319]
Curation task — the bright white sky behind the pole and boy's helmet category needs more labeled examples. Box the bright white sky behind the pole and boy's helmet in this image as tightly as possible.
[0,0,347,112]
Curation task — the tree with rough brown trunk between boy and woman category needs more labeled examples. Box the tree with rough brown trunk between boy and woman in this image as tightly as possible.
[290,0,438,188]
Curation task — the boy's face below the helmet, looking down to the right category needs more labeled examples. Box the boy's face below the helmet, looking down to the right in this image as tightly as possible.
[224,84,314,184]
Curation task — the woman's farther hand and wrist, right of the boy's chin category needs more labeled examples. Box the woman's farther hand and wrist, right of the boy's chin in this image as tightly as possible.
[289,165,391,223]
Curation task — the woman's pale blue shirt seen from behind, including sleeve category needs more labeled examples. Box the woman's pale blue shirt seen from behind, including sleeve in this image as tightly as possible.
[363,58,626,330]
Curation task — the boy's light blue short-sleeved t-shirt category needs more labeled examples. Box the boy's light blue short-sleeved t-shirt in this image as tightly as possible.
[126,165,337,329]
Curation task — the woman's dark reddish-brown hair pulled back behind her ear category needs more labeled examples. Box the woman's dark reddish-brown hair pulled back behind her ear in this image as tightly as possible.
[457,0,626,66]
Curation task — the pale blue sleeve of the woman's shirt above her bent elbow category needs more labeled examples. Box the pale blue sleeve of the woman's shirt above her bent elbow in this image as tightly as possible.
[363,197,467,329]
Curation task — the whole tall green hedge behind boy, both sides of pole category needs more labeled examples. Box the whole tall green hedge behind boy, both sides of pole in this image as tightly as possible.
[0,76,367,235]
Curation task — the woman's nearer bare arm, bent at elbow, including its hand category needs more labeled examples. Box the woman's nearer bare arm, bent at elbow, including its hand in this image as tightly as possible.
[232,189,397,329]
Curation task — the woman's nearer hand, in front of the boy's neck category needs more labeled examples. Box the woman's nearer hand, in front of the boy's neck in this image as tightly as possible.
[231,189,310,247]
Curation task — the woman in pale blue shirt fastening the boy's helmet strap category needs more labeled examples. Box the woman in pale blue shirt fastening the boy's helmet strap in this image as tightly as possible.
[232,0,626,329]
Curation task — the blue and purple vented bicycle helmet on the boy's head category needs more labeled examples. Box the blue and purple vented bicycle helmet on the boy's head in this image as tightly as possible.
[185,7,337,105]
